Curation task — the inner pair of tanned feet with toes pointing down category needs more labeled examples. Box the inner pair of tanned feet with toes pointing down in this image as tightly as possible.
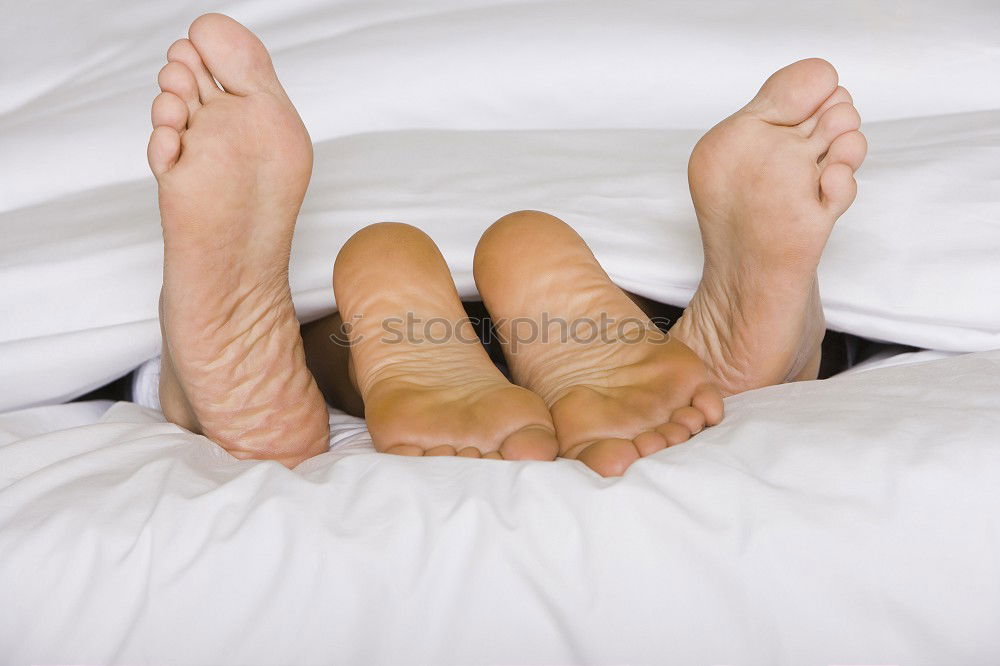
[333,211,722,475]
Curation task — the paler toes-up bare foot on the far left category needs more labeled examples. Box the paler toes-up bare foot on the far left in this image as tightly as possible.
[148,14,329,467]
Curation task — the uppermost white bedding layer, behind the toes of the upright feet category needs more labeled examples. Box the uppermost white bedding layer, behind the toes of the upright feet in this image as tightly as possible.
[0,0,1000,210]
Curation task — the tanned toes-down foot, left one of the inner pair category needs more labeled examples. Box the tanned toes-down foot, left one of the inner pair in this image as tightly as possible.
[333,223,558,460]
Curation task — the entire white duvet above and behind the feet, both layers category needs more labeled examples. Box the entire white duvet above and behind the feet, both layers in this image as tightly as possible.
[0,0,1000,411]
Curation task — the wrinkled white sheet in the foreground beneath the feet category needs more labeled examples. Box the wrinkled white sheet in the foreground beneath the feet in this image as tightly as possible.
[0,352,1000,666]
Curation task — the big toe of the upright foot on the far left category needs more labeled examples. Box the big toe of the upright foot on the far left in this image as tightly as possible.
[188,14,281,95]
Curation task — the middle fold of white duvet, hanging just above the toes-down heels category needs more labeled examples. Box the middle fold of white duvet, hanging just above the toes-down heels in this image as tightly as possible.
[0,116,1000,412]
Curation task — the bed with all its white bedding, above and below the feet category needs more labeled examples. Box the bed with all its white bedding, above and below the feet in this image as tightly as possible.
[0,0,1000,664]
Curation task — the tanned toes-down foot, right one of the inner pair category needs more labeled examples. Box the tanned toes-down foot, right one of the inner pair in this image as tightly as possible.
[475,211,722,476]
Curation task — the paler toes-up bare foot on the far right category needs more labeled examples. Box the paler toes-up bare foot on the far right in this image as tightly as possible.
[670,59,867,395]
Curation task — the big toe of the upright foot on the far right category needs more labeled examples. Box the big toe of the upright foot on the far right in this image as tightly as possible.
[747,58,837,125]
